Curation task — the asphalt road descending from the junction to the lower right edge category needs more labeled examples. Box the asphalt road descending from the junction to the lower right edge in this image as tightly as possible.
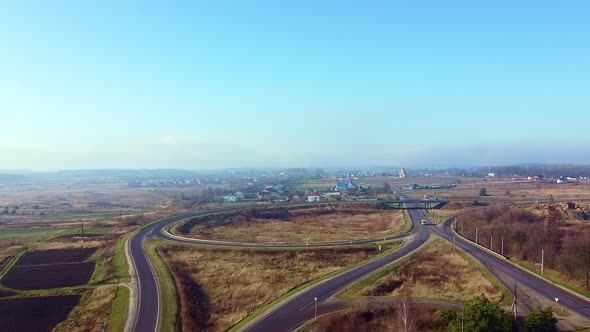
[432,218,590,318]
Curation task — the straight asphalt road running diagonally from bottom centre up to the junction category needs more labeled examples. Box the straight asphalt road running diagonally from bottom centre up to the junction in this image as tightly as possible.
[245,210,429,332]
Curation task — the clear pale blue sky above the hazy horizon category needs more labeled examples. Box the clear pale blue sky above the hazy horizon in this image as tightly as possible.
[0,0,590,171]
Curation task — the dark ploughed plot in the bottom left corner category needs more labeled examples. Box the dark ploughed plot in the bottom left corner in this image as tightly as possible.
[0,295,80,332]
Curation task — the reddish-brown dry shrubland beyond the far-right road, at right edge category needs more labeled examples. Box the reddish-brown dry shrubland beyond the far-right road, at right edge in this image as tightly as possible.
[457,204,590,290]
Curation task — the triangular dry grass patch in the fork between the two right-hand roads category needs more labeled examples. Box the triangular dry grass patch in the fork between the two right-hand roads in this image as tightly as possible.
[361,241,502,301]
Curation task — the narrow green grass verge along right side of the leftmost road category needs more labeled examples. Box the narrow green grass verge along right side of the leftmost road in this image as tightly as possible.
[144,240,182,331]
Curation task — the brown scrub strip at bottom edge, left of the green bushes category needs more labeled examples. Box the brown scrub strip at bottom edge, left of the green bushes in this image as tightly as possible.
[302,304,437,332]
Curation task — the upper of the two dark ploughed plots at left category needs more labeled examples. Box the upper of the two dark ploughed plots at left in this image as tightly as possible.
[2,249,96,290]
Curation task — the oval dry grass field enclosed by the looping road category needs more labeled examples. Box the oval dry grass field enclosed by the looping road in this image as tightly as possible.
[179,204,405,243]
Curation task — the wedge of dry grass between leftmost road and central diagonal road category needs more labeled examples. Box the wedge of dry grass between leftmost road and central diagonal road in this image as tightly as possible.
[159,245,386,331]
